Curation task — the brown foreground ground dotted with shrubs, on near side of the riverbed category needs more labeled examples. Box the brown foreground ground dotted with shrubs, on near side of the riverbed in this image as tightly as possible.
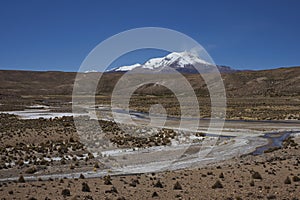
[0,133,300,200]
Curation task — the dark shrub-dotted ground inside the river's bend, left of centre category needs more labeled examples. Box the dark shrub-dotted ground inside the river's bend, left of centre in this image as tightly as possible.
[0,114,183,178]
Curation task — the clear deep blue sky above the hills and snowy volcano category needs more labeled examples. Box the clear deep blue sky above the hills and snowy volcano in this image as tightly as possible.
[0,0,300,71]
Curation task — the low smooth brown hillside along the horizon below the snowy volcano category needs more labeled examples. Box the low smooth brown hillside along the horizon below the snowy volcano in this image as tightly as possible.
[0,67,300,97]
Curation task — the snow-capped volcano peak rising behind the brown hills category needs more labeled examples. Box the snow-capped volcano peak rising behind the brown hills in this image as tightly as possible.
[110,51,237,73]
